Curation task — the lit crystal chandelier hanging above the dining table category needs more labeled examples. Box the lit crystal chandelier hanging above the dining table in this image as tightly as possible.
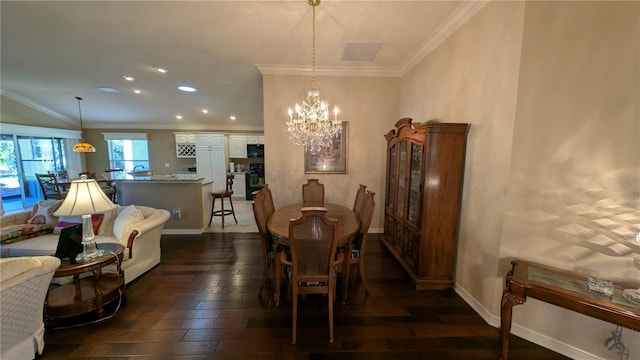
[286,0,342,150]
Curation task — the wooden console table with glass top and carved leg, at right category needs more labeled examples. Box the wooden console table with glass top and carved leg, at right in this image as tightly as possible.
[500,260,640,360]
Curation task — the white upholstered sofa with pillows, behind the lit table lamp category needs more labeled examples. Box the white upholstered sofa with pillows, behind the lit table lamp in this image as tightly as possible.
[0,206,170,283]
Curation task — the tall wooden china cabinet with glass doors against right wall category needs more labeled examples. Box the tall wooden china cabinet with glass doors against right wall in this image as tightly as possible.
[383,118,470,290]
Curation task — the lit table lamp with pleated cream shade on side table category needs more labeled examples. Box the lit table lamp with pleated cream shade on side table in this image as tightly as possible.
[53,175,116,261]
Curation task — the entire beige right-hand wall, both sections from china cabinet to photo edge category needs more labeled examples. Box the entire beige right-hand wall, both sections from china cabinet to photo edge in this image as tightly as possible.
[401,2,640,358]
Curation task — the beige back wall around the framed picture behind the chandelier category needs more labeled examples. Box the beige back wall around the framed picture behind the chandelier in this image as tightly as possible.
[263,75,400,231]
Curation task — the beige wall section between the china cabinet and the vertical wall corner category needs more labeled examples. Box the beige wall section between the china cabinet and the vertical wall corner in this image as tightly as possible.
[402,2,524,308]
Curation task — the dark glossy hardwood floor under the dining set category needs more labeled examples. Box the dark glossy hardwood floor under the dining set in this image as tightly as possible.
[40,233,566,360]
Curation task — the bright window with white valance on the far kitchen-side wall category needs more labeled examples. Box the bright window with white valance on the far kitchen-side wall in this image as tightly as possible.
[103,133,149,171]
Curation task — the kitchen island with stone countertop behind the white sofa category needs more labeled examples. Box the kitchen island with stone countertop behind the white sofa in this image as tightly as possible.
[112,174,213,234]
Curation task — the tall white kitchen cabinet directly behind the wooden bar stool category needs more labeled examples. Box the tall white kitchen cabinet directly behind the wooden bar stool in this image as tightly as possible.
[195,133,227,189]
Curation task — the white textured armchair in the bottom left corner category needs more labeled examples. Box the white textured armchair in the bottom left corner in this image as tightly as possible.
[0,256,60,360]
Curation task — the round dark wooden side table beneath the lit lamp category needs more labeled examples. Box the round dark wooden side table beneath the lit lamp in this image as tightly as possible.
[45,243,125,322]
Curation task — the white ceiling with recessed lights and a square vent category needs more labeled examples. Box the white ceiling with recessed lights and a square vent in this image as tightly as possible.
[0,0,485,130]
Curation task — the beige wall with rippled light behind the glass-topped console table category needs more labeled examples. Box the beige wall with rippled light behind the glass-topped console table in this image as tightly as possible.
[501,2,640,358]
